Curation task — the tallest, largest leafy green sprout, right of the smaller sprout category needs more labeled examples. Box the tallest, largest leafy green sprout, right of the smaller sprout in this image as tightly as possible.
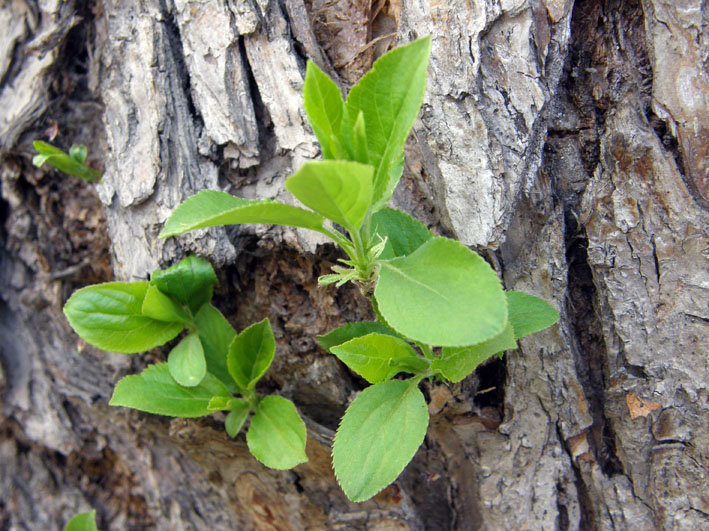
[156,38,558,502]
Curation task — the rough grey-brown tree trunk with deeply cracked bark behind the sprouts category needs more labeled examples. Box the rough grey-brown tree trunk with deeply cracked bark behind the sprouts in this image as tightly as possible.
[0,0,709,529]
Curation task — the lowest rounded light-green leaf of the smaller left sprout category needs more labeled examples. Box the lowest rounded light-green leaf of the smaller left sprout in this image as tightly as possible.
[246,395,308,470]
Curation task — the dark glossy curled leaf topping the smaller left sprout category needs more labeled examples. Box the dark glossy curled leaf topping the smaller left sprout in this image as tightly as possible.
[150,255,217,314]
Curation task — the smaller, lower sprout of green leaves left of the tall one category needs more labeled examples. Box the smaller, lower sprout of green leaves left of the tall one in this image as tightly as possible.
[64,256,307,469]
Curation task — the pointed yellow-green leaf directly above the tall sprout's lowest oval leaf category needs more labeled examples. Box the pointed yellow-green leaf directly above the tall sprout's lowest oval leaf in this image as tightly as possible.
[331,334,424,383]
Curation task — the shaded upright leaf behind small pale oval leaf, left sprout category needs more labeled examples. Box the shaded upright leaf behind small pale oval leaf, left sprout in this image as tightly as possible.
[194,304,241,391]
